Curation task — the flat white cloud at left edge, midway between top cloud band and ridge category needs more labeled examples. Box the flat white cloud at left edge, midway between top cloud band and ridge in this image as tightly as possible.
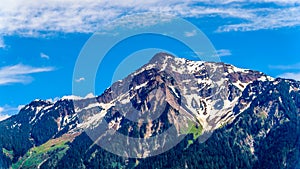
[0,64,54,85]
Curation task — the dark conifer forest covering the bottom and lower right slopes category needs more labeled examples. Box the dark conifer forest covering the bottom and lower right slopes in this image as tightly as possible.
[42,81,300,169]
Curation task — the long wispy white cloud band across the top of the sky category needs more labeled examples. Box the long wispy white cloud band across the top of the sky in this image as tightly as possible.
[0,0,300,36]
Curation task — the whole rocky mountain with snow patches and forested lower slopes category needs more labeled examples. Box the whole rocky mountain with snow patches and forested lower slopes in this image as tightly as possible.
[0,53,300,169]
